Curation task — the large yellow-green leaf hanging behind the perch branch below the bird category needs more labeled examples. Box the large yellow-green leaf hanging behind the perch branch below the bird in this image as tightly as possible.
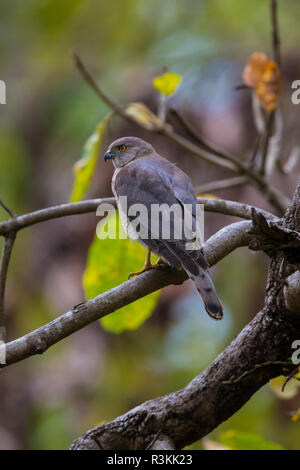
[83,212,159,333]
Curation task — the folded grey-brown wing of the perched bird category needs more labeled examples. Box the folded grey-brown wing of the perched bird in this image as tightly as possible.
[114,156,207,273]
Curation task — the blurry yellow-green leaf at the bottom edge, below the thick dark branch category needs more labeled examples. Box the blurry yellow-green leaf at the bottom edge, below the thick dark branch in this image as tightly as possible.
[220,430,284,450]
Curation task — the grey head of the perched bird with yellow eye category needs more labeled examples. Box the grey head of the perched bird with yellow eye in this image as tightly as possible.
[104,137,155,168]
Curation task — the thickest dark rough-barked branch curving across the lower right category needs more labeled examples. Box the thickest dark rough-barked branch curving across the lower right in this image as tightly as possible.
[70,310,300,450]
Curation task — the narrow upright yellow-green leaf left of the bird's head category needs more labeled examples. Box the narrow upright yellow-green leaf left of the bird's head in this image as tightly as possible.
[70,116,110,202]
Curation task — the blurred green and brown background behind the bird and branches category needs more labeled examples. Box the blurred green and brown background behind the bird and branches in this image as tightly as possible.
[0,0,300,449]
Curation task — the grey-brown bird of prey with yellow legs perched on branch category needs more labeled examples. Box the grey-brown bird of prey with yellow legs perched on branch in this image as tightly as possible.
[104,137,223,320]
